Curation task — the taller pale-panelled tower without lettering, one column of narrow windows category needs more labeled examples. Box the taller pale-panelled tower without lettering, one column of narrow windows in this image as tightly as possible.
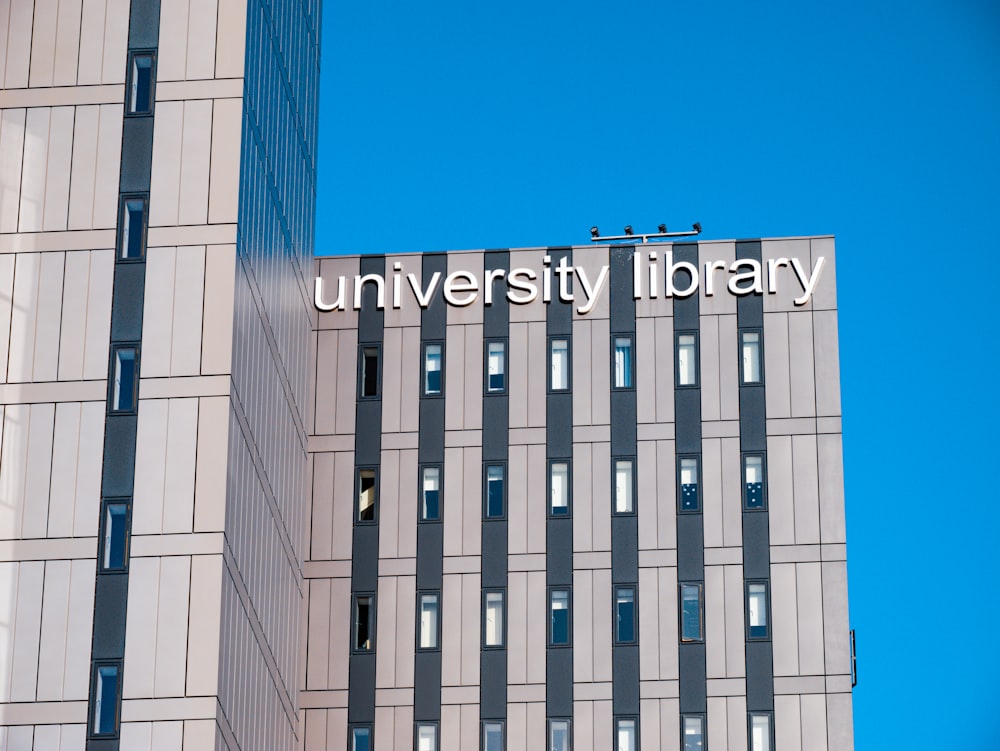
[0,0,320,751]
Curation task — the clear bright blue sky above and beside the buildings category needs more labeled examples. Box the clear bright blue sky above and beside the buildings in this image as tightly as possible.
[317,0,1000,751]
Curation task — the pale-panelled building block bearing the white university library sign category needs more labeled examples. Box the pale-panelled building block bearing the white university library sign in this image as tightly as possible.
[301,242,853,751]
